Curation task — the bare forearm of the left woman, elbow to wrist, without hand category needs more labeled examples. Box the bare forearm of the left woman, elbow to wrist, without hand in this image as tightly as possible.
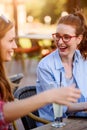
[4,93,50,122]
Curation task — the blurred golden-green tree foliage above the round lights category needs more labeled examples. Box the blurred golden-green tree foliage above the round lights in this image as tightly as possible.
[26,0,66,24]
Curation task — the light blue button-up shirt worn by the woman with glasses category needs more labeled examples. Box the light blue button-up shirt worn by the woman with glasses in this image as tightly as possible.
[36,49,87,126]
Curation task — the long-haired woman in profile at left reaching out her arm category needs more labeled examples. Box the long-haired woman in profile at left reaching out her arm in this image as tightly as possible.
[0,15,80,130]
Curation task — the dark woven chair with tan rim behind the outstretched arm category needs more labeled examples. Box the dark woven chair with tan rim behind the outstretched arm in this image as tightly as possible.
[14,86,50,130]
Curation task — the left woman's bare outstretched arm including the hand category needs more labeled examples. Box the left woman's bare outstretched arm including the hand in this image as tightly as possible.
[3,87,80,122]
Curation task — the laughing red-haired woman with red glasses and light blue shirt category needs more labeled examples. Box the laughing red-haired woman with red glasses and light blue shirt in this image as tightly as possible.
[36,10,87,125]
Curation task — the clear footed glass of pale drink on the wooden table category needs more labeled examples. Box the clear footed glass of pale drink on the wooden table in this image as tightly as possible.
[52,103,66,128]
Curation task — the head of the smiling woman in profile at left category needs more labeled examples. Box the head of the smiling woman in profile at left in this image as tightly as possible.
[0,16,17,61]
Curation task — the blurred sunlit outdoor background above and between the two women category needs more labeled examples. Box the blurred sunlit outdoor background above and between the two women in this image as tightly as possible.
[0,0,87,85]
